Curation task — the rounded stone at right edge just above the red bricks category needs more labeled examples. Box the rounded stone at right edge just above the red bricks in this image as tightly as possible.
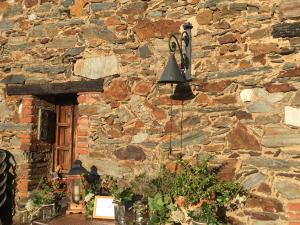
[275,180,300,200]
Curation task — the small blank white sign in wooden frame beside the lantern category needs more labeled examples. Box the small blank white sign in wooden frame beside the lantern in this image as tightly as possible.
[93,196,115,220]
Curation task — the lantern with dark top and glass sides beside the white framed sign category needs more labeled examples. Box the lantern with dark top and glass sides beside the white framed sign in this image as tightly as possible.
[66,160,87,214]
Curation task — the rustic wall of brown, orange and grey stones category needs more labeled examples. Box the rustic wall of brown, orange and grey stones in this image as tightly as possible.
[0,0,300,225]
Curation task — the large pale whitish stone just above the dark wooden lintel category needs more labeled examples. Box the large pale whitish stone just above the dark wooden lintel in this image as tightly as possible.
[74,55,120,79]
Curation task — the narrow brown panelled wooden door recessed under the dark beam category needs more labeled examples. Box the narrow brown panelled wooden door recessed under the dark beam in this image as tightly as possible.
[53,105,75,173]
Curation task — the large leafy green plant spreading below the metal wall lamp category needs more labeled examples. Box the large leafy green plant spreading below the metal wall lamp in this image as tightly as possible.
[135,160,245,225]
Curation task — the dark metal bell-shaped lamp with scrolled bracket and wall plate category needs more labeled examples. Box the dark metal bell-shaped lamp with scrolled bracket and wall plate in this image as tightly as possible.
[158,23,193,84]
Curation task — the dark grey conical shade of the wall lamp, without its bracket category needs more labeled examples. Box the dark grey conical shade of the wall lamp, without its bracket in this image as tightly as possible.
[158,54,185,84]
